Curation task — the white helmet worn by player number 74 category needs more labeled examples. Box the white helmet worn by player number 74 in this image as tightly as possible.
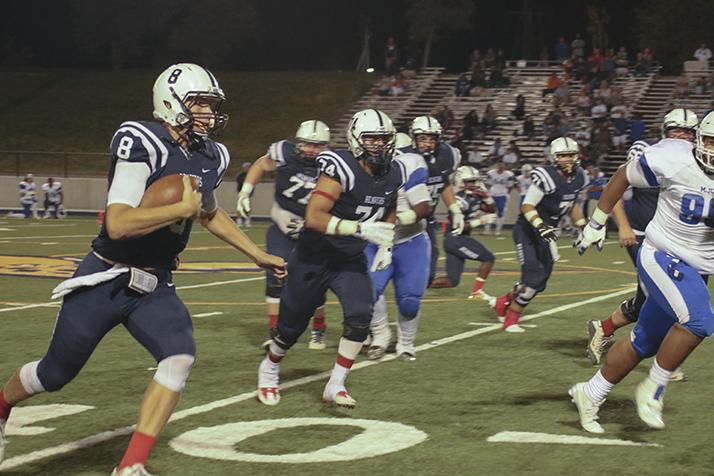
[347,109,397,173]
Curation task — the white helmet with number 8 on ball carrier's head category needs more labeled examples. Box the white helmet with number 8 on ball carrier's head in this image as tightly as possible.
[153,63,228,143]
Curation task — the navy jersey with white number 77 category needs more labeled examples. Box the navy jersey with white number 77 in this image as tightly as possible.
[268,140,319,217]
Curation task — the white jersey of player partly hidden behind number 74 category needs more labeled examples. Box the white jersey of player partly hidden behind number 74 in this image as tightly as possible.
[394,152,431,244]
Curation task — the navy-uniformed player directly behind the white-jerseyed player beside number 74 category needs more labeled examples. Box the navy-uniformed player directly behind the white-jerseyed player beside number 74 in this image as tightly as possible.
[401,116,464,284]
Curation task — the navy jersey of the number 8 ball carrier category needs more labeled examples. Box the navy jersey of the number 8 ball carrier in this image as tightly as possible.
[92,121,230,269]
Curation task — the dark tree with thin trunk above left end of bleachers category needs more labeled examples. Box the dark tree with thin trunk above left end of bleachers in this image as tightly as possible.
[406,0,474,67]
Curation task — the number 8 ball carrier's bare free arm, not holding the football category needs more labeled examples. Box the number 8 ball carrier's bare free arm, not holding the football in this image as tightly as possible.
[200,208,286,278]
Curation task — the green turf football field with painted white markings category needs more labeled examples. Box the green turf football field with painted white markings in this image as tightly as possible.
[0,218,714,476]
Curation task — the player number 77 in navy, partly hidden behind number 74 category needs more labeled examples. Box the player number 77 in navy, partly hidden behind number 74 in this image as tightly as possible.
[236,119,330,350]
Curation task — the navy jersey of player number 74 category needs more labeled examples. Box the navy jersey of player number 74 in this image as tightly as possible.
[298,150,407,258]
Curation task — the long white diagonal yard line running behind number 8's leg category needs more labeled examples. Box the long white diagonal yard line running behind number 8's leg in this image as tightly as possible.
[0,289,632,471]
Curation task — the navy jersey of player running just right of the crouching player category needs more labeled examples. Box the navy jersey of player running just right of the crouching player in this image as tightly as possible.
[518,165,588,227]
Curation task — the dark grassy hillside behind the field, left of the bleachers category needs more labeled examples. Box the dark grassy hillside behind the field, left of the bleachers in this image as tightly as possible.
[0,69,375,176]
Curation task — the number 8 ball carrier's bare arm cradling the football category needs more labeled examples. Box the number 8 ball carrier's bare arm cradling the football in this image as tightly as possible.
[106,174,201,240]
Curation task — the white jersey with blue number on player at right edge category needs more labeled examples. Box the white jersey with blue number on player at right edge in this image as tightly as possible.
[626,139,714,275]
